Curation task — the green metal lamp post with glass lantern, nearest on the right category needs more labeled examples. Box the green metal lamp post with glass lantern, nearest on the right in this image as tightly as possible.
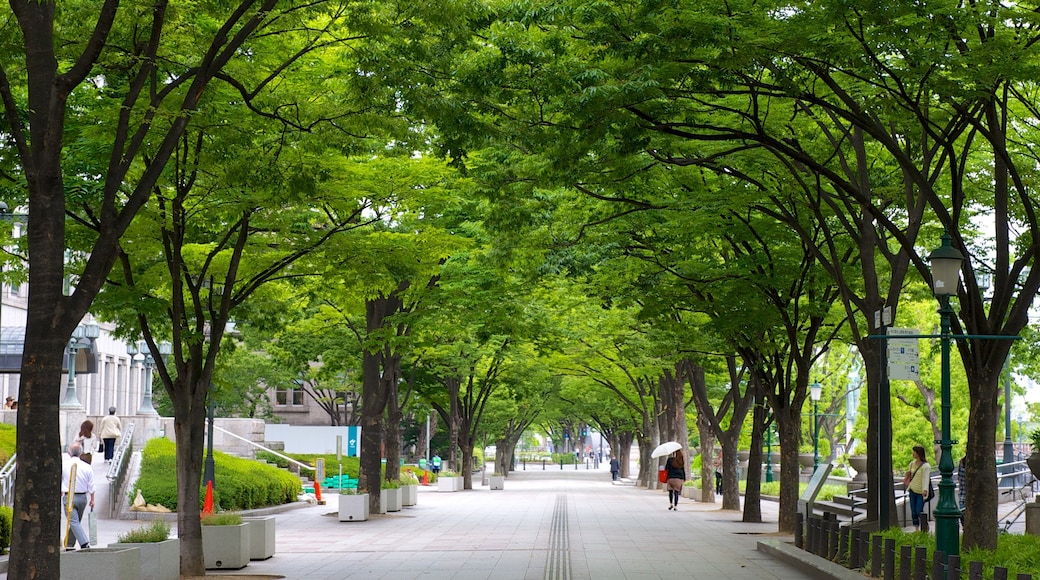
[928,233,964,556]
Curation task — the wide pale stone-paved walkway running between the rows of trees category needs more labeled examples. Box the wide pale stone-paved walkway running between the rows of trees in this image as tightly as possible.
[18,466,808,580]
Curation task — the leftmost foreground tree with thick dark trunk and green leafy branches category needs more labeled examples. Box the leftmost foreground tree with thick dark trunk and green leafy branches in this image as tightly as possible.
[0,0,370,578]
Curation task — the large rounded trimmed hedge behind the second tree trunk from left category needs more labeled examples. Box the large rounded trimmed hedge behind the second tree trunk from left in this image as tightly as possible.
[130,439,303,511]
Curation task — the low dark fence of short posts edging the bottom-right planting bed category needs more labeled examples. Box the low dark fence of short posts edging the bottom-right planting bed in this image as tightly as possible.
[795,513,1033,580]
